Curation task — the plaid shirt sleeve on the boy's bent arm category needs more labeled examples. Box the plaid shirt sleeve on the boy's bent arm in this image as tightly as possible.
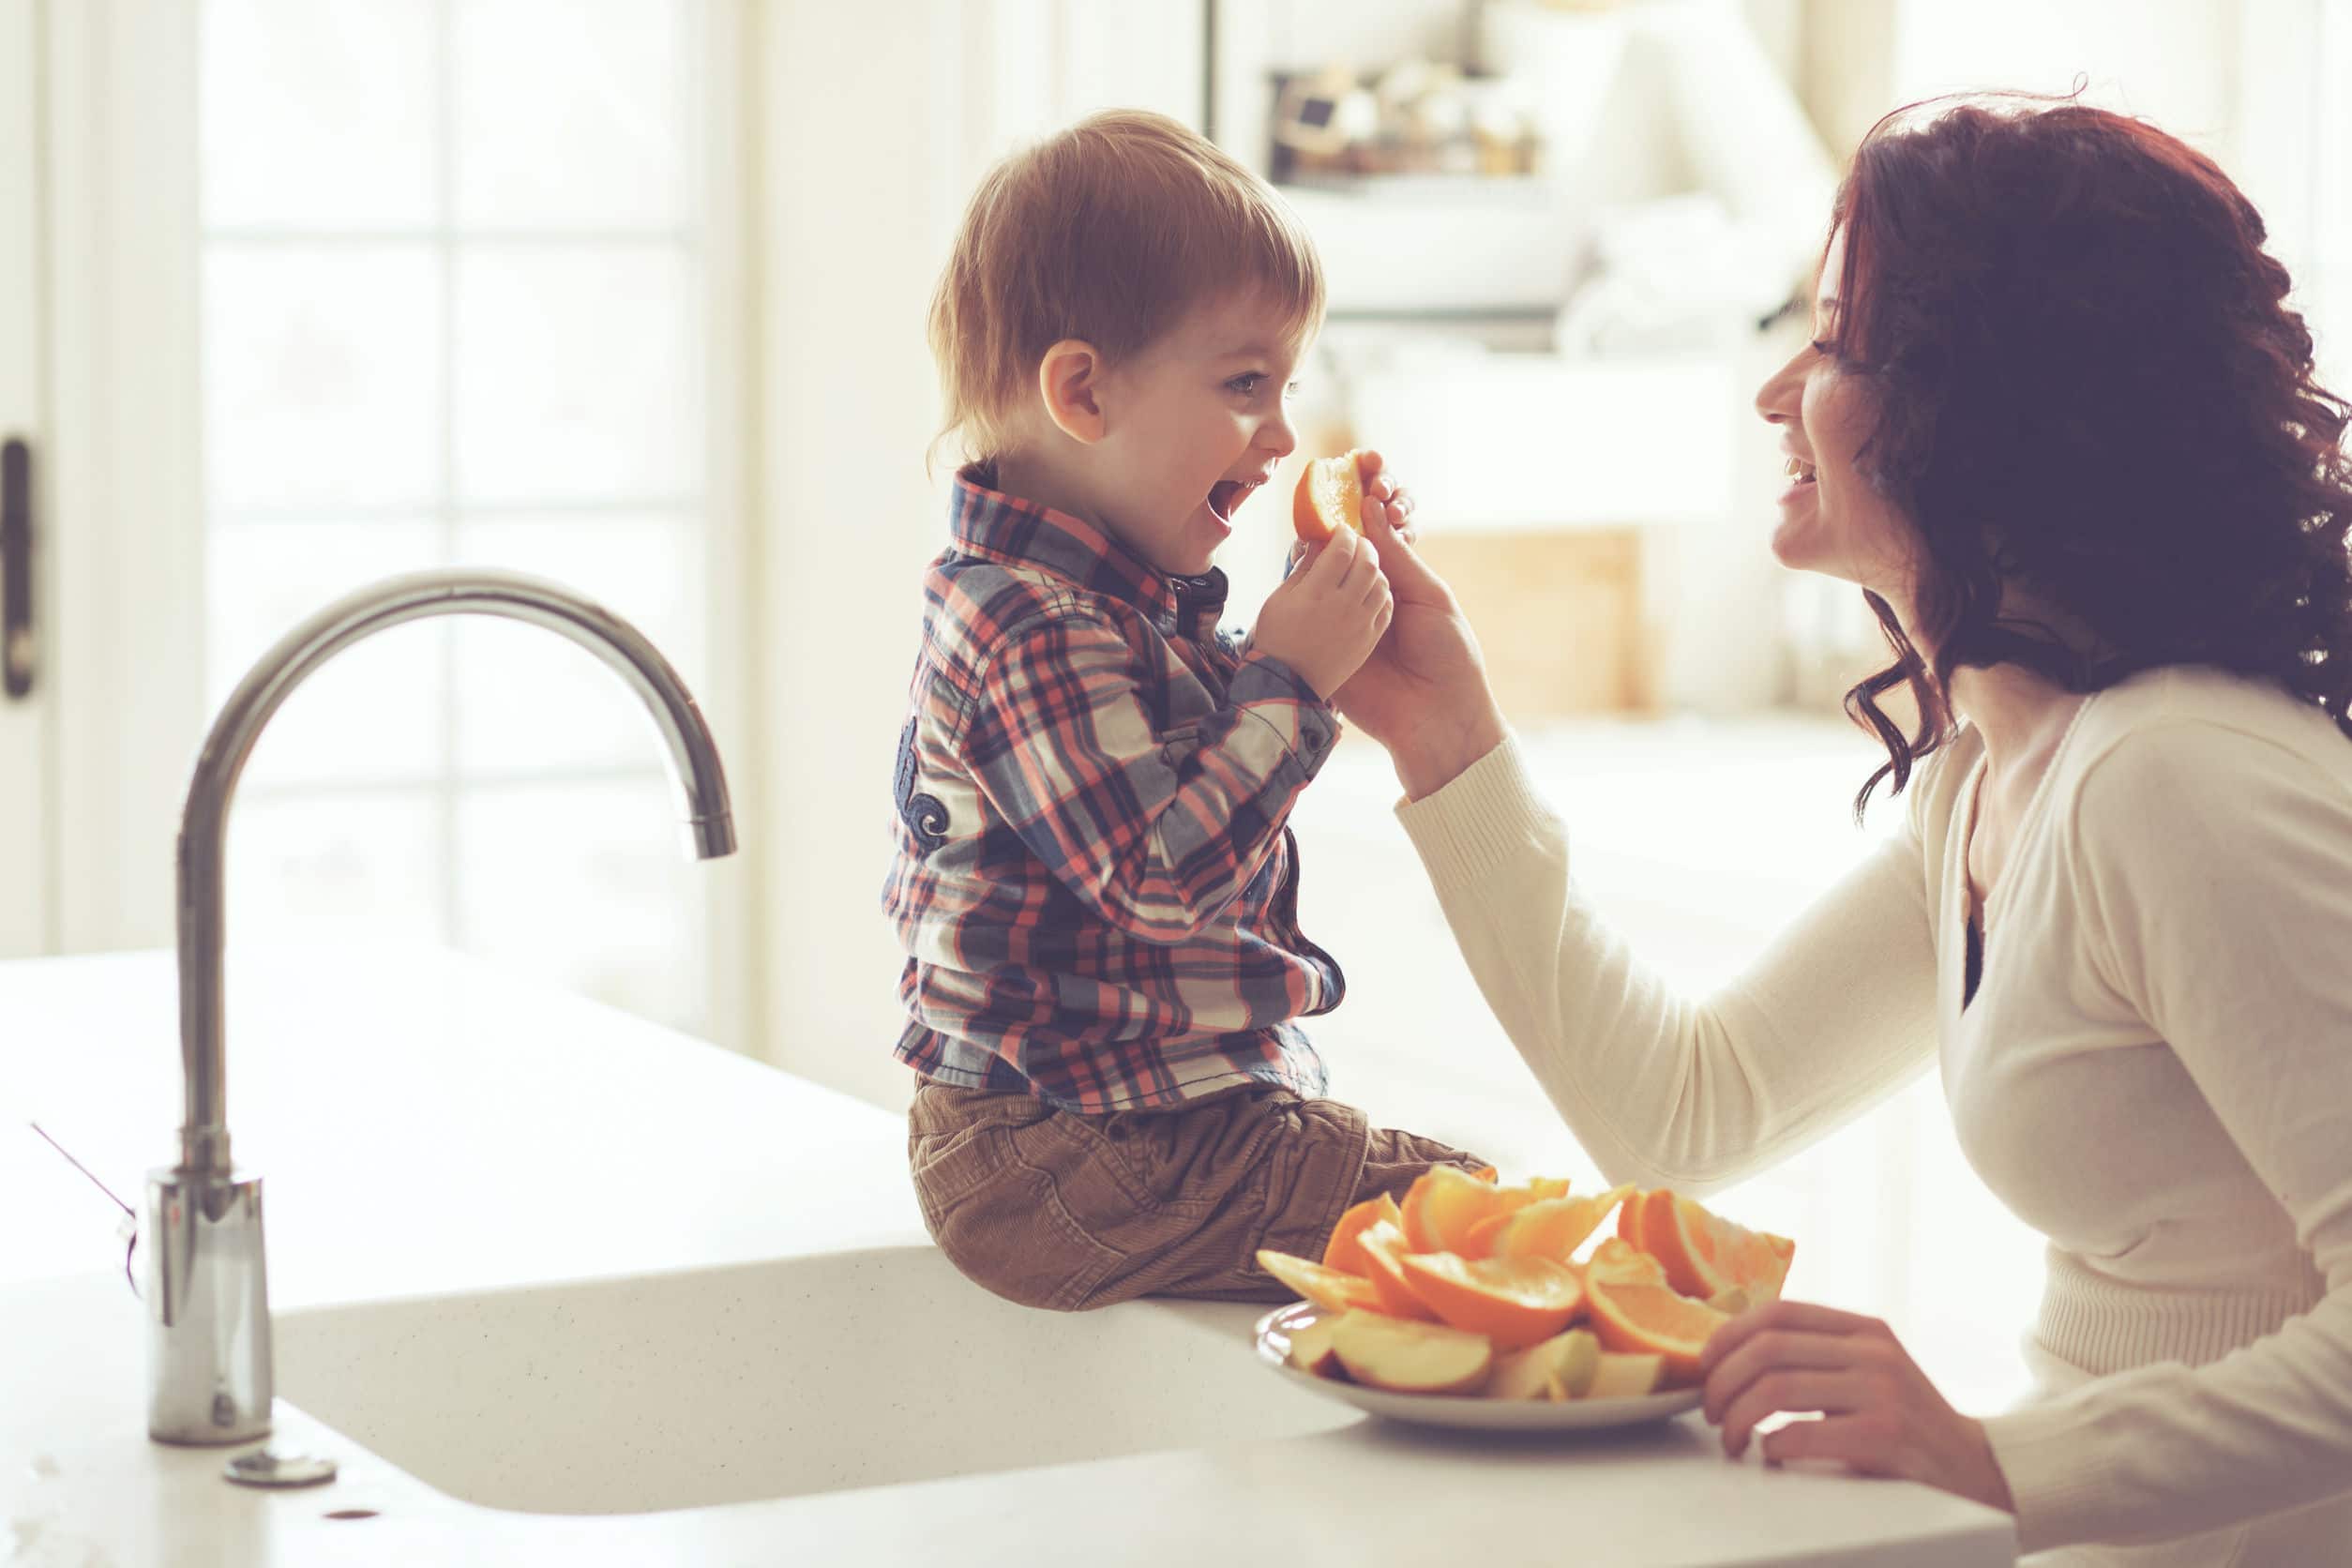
[959,616,1338,942]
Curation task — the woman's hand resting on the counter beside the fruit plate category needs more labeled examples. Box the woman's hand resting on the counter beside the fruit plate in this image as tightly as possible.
[1698,1303,2015,1514]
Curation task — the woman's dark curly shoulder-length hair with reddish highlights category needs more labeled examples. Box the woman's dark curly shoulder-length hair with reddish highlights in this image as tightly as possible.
[1823,94,2352,818]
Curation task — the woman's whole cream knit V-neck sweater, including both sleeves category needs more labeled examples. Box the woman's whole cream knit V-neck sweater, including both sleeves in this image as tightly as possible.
[1397,668,2352,1563]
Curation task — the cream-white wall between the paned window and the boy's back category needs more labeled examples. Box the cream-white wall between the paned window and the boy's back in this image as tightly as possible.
[739,0,1202,1105]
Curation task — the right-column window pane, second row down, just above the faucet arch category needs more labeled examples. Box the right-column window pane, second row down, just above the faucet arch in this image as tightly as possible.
[457,245,701,505]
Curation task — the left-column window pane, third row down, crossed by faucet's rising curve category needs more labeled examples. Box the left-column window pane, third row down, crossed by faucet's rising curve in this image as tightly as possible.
[204,520,447,785]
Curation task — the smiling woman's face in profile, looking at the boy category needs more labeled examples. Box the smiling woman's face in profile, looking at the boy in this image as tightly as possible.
[1756,228,1915,609]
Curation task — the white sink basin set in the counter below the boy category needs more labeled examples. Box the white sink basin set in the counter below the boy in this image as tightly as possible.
[273,1246,1362,1514]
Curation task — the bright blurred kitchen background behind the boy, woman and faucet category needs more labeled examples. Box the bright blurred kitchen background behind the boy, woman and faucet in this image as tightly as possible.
[0,0,2352,1410]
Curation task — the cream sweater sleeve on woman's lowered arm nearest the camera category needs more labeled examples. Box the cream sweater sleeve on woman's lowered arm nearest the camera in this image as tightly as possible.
[1985,722,2352,1551]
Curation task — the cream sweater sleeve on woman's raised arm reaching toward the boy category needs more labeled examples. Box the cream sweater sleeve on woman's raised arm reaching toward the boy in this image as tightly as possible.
[1397,741,1936,1197]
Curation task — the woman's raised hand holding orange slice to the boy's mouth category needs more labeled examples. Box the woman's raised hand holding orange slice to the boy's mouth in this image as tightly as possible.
[1332,451,1503,799]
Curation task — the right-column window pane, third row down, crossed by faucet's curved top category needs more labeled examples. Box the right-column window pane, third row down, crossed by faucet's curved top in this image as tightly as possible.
[457,515,705,776]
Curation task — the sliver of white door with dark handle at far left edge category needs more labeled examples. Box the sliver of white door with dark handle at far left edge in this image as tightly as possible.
[0,0,56,959]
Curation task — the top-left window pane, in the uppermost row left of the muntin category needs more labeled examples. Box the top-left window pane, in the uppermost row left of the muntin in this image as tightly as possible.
[200,0,440,231]
